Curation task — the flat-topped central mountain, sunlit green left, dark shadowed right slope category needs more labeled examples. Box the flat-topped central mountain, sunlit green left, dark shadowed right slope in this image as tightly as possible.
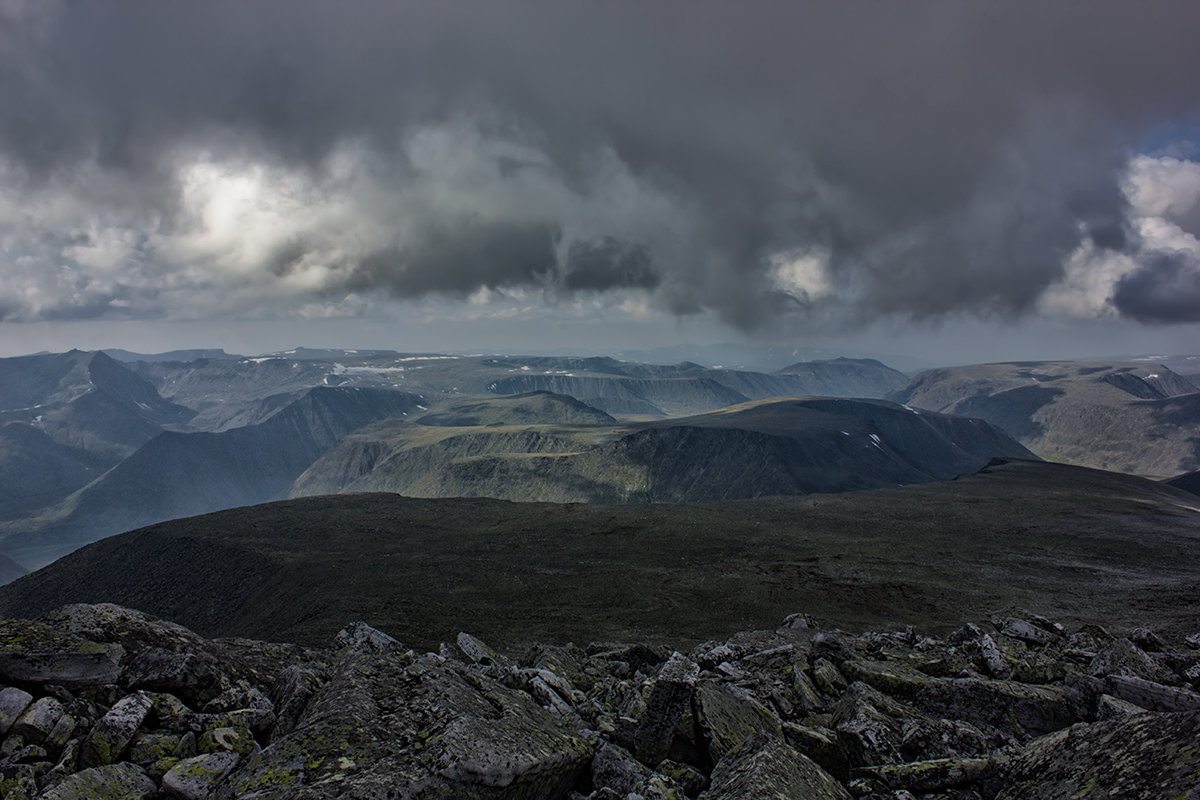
[292,395,1033,503]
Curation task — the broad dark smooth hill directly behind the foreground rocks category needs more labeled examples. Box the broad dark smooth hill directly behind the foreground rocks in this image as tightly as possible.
[0,462,1200,648]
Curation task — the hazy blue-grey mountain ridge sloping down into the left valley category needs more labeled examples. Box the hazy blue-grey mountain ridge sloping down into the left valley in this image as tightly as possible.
[4,389,421,565]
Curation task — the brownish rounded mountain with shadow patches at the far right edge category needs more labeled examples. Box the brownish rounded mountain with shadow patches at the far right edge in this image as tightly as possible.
[888,361,1200,477]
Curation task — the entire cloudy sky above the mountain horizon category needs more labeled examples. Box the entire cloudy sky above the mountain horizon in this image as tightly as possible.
[0,0,1200,362]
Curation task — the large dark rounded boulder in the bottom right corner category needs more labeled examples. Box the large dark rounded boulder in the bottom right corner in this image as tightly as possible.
[996,711,1200,800]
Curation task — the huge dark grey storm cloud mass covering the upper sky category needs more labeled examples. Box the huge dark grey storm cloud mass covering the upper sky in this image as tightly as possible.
[0,0,1200,327]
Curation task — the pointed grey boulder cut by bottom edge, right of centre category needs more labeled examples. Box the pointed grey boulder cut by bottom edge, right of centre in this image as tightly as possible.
[700,734,851,800]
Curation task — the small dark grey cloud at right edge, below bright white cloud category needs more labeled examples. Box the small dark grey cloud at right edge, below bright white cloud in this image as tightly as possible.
[1112,252,1200,323]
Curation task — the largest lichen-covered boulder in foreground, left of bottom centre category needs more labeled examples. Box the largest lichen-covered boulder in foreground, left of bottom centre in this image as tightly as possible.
[220,650,596,800]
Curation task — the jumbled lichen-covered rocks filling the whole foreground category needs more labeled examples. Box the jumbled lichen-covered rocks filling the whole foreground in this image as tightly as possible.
[0,604,1200,800]
